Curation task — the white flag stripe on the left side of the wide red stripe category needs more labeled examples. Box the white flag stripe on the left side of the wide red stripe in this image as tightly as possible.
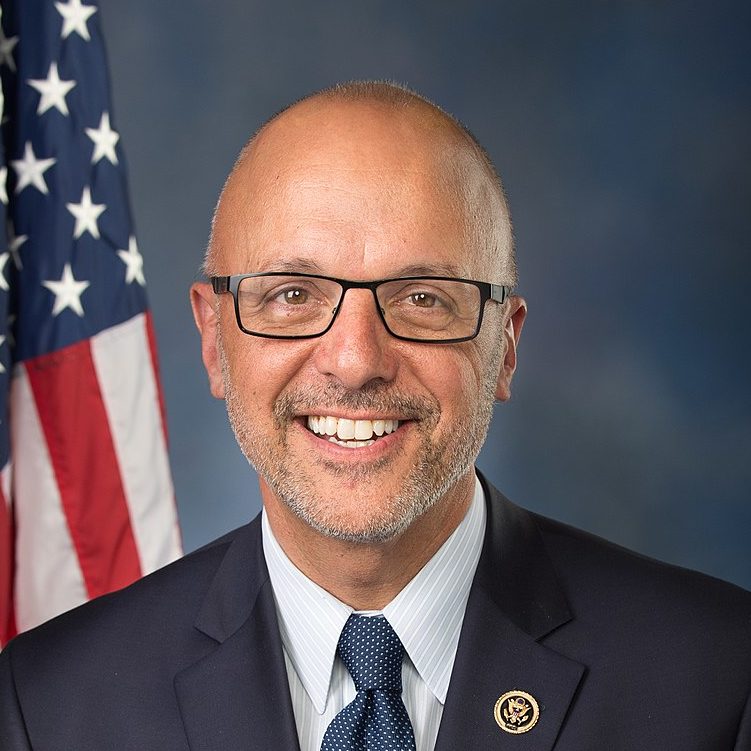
[10,365,87,631]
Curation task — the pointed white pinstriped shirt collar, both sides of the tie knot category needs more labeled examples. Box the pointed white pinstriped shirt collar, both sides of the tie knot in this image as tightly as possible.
[261,479,487,714]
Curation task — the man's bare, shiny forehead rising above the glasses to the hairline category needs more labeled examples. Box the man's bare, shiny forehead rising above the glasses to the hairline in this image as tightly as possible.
[214,98,500,278]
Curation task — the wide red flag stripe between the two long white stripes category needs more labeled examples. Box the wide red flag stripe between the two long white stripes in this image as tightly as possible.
[25,341,141,597]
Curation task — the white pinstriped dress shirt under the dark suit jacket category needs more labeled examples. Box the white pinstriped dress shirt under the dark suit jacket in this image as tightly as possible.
[262,479,486,751]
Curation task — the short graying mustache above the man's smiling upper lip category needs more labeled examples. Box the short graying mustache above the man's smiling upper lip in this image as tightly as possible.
[273,381,441,427]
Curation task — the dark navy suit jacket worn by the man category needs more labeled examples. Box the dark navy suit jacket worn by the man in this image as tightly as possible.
[0,478,751,751]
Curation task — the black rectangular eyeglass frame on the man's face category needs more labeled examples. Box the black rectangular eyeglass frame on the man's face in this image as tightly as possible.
[209,271,513,344]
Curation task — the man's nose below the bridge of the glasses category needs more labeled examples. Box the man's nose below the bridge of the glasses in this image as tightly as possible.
[313,289,397,389]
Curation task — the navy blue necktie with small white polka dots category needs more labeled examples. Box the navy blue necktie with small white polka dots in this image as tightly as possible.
[321,615,415,751]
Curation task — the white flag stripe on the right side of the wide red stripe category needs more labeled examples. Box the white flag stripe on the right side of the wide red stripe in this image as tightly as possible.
[91,314,181,574]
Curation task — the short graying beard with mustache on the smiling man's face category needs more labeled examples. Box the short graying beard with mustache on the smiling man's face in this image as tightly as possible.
[220,340,499,544]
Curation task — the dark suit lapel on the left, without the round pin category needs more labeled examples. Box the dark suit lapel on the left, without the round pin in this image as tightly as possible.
[175,520,299,751]
